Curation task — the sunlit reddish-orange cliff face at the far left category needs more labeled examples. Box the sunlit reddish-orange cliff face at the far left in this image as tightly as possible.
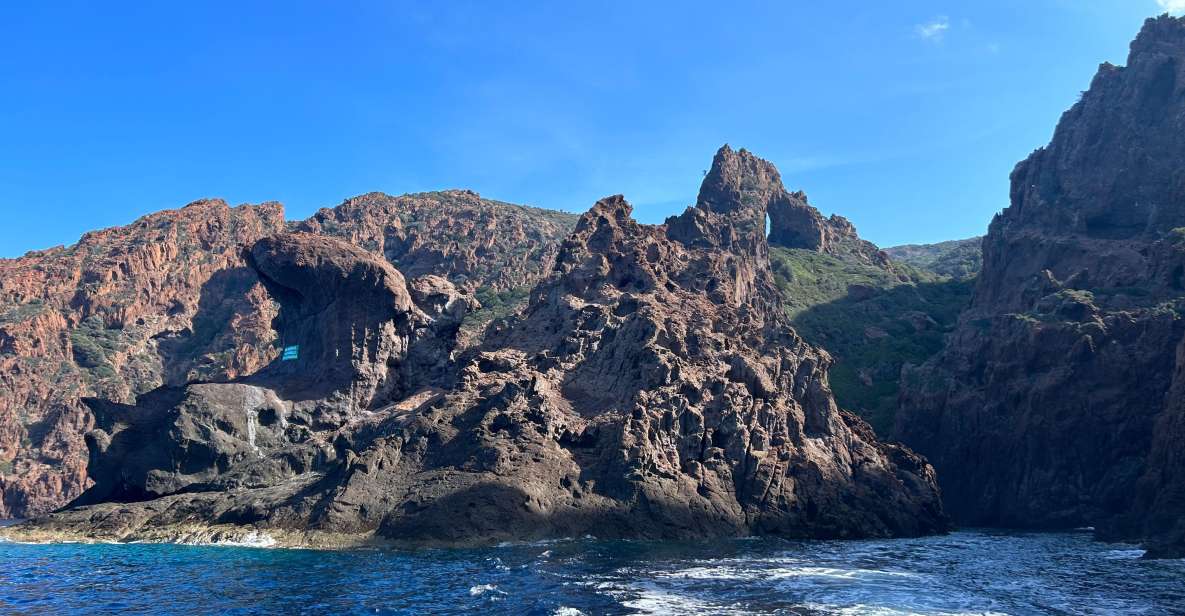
[0,200,284,518]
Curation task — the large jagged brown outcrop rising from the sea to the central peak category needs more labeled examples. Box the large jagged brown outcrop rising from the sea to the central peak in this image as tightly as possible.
[9,147,946,545]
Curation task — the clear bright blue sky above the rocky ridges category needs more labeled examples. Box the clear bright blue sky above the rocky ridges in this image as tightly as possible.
[0,0,1185,256]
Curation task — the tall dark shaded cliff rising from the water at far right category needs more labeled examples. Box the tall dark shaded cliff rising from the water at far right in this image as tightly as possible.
[898,17,1185,554]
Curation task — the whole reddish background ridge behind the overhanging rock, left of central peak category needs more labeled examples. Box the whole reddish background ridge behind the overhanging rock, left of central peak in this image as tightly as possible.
[0,191,576,518]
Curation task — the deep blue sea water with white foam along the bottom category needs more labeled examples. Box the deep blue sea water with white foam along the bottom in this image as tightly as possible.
[0,532,1185,616]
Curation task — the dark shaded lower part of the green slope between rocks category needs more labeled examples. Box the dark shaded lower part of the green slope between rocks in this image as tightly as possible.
[792,278,975,437]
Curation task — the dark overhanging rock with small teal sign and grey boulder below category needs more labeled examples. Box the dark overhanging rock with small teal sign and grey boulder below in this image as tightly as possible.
[70,233,469,503]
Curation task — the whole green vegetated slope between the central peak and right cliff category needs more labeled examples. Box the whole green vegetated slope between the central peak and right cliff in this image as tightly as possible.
[770,246,973,434]
